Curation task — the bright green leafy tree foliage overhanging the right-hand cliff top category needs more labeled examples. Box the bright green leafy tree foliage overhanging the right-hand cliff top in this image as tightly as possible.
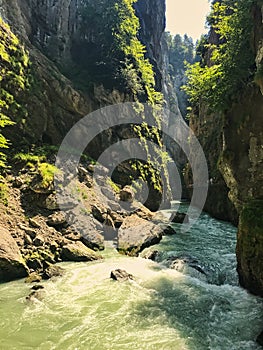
[184,0,255,110]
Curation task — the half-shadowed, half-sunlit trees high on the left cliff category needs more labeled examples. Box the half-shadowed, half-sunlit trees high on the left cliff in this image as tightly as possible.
[76,0,162,104]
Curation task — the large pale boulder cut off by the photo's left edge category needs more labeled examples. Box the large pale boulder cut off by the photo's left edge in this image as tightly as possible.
[0,226,29,281]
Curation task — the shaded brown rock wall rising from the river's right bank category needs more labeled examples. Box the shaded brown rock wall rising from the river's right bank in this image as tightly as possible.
[191,6,263,296]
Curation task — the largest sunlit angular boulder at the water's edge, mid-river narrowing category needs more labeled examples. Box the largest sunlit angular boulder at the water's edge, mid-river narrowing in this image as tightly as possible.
[117,214,162,256]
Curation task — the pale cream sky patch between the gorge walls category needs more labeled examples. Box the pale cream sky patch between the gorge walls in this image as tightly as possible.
[166,0,210,42]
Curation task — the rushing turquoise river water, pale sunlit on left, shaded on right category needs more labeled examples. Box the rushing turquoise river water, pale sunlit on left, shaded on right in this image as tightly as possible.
[0,206,263,350]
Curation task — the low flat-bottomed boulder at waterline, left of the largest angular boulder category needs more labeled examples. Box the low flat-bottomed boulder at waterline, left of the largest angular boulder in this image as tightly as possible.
[61,242,101,261]
